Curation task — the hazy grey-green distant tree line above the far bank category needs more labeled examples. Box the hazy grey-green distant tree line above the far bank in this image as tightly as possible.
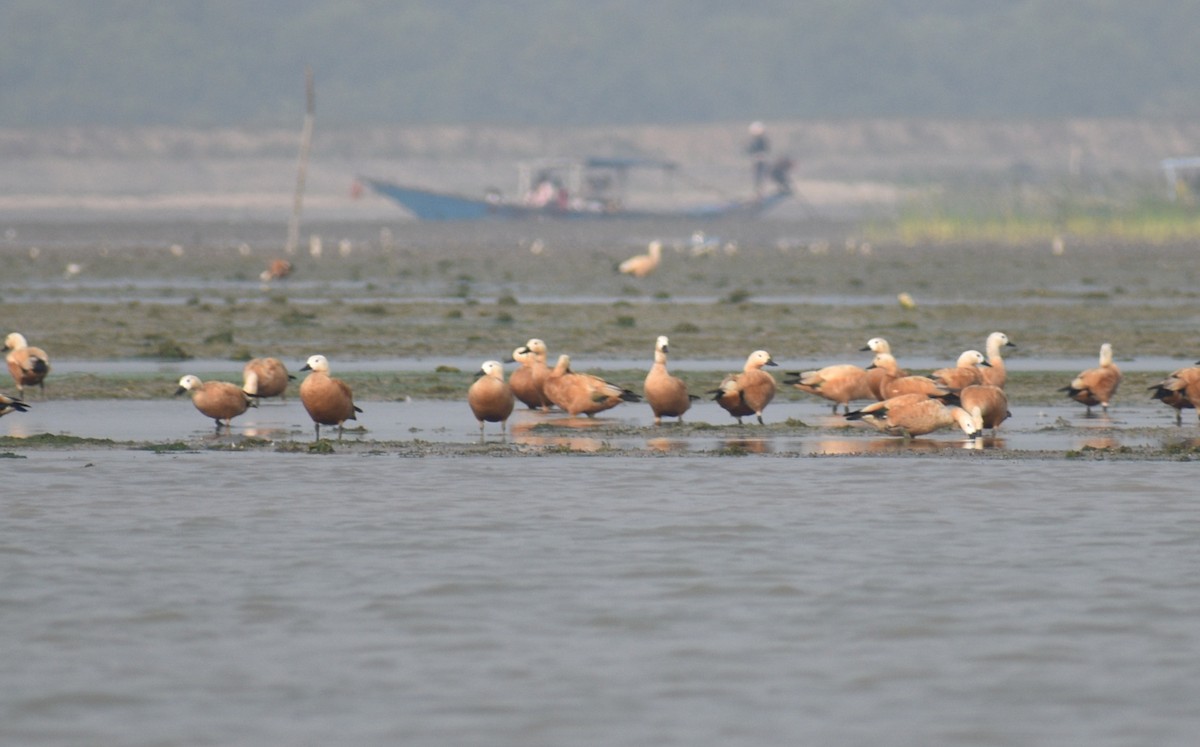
[0,0,1200,127]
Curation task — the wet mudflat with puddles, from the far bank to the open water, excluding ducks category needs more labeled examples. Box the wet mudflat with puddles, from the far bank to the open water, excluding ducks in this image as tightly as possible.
[0,220,1200,458]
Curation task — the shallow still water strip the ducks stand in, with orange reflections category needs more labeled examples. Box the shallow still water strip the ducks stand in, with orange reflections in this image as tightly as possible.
[0,398,1200,455]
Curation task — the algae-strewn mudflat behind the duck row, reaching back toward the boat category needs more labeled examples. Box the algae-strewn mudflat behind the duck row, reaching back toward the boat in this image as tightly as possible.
[7,232,1200,370]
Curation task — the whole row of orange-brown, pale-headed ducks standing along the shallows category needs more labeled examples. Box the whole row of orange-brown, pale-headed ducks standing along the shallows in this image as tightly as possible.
[0,324,1200,440]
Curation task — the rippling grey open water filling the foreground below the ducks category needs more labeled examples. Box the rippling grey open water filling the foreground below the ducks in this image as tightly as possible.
[0,449,1200,746]
